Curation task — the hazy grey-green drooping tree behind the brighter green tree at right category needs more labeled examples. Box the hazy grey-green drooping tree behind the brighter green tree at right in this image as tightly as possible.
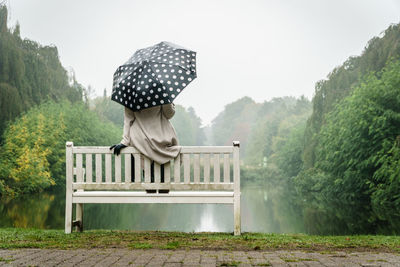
[303,24,400,168]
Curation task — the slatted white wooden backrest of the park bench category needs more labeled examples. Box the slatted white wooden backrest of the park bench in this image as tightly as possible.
[66,141,240,192]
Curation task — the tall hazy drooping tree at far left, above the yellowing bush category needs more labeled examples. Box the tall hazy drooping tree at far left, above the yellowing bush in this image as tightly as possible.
[0,4,82,141]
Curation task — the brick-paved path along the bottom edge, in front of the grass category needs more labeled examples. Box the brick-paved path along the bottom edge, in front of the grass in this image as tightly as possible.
[0,249,400,267]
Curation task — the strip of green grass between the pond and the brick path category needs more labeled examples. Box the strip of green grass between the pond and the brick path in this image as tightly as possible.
[0,228,400,253]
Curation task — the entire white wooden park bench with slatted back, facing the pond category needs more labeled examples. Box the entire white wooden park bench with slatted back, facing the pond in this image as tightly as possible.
[65,141,241,235]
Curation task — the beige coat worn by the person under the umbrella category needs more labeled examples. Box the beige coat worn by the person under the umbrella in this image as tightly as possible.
[121,104,181,164]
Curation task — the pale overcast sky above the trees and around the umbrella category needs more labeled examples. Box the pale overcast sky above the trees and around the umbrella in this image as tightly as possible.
[8,0,400,124]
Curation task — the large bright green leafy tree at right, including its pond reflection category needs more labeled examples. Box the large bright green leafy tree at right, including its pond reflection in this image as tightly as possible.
[298,61,400,233]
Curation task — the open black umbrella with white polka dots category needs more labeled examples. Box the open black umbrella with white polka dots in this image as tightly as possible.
[111,42,197,111]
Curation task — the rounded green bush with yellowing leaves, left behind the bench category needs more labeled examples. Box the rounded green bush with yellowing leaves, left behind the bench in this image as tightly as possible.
[0,101,122,196]
